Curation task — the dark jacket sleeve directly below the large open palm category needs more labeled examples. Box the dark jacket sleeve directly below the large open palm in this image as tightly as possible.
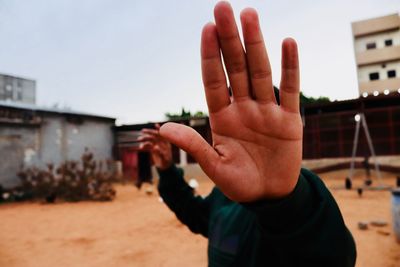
[244,169,356,267]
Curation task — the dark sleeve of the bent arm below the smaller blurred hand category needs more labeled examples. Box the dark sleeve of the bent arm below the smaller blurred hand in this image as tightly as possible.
[158,165,212,237]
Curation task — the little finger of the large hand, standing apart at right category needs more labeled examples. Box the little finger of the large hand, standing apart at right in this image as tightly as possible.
[279,38,300,112]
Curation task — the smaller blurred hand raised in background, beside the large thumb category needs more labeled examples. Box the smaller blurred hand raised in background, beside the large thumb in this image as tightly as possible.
[138,124,172,170]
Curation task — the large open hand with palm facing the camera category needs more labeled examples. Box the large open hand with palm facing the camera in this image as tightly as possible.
[160,2,302,202]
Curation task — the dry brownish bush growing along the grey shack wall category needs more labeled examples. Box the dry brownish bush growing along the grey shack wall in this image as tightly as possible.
[10,150,116,203]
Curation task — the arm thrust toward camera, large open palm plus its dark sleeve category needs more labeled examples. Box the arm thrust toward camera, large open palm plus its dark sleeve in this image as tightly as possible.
[160,1,355,266]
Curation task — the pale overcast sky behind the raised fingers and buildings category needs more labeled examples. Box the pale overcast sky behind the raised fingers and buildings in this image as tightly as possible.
[0,0,400,123]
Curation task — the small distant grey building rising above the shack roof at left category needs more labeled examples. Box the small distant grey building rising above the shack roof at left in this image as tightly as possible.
[0,74,36,104]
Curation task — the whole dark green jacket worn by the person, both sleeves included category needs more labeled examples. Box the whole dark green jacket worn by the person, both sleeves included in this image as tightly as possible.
[158,166,356,267]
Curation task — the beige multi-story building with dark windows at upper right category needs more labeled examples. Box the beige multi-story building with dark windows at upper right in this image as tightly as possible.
[352,14,400,97]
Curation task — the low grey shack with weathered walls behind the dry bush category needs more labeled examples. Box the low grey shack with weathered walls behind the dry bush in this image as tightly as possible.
[0,101,115,188]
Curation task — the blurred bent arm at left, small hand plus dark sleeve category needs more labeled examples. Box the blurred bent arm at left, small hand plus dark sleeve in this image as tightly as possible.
[138,124,213,237]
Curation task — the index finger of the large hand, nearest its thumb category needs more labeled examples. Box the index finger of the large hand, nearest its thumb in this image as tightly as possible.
[201,23,230,113]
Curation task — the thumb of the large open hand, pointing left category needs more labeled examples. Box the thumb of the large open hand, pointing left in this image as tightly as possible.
[160,122,219,178]
